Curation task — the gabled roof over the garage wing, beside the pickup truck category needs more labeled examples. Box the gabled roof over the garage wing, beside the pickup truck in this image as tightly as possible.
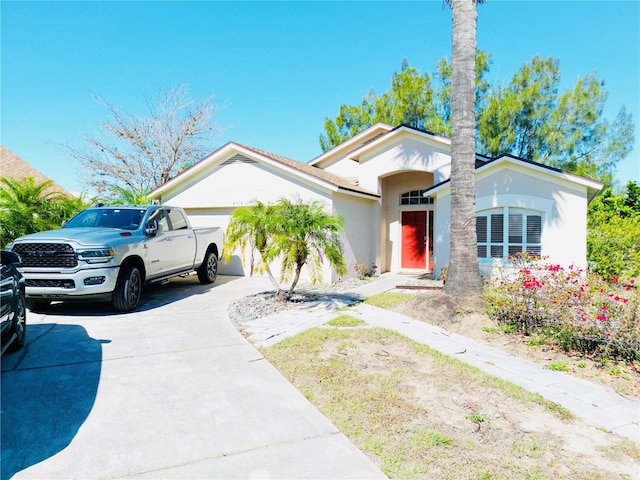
[149,142,379,198]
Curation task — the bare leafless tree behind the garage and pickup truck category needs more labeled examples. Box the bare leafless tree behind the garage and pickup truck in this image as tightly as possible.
[63,83,222,195]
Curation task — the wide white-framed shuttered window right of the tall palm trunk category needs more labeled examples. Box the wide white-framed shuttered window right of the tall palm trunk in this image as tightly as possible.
[476,207,542,258]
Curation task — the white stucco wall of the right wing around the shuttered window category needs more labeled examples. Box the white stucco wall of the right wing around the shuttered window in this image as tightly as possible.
[435,165,587,273]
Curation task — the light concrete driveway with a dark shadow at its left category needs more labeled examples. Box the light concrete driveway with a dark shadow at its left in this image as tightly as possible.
[1,276,386,480]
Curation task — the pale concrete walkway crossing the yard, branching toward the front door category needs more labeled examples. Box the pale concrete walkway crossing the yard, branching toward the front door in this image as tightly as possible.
[244,274,640,442]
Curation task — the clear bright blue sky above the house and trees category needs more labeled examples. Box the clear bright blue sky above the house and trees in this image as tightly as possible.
[0,0,640,192]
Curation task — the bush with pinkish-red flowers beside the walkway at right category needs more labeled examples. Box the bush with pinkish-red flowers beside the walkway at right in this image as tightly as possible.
[485,254,640,361]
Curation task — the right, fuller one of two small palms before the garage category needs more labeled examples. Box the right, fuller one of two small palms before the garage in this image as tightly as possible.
[268,199,347,299]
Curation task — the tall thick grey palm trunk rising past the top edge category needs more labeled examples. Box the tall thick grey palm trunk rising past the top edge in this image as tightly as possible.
[445,0,482,297]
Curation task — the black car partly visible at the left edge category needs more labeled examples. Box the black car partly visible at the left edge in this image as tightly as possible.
[0,250,27,353]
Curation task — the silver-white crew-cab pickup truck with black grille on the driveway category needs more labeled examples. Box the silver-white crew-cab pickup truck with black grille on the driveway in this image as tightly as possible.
[7,205,222,312]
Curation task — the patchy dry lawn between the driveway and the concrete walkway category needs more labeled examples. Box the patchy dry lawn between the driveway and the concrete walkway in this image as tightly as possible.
[262,326,640,479]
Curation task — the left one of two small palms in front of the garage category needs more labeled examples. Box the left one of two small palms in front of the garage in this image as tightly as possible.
[222,200,280,294]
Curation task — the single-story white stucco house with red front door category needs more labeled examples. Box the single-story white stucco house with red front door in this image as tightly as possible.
[150,124,602,281]
